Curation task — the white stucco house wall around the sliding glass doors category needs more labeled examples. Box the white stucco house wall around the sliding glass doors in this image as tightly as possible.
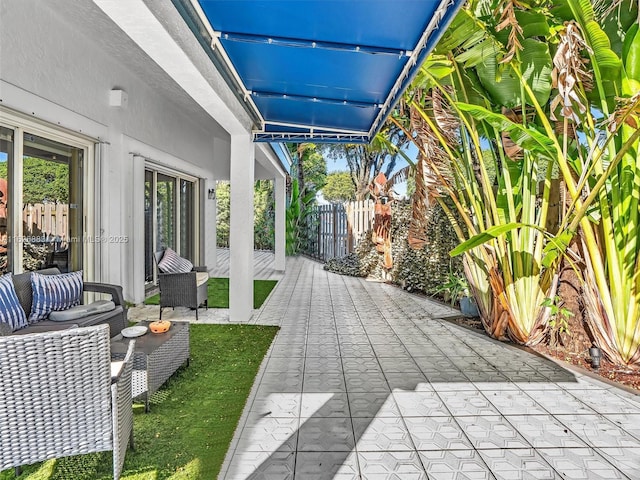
[0,0,236,302]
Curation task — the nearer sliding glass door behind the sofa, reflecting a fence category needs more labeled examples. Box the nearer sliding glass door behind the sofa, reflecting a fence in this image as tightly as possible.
[0,119,88,273]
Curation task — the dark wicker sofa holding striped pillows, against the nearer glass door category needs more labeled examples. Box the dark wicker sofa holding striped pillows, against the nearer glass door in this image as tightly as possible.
[13,268,128,337]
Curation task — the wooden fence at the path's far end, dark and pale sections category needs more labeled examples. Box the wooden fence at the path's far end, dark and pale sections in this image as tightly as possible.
[305,201,373,262]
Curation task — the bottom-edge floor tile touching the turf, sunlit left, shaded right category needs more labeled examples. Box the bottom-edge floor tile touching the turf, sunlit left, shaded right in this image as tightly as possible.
[224,452,295,480]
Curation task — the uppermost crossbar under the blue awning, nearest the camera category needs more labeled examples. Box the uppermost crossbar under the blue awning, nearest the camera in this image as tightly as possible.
[215,31,413,57]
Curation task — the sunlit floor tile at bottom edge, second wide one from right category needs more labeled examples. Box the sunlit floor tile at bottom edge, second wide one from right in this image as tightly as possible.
[478,448,562,480]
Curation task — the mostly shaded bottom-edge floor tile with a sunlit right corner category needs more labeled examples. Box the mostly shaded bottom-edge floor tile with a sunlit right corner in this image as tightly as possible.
[296,452,360,480]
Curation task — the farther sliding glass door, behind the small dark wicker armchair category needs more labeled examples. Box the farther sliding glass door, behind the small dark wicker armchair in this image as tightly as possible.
[144,168,197,284]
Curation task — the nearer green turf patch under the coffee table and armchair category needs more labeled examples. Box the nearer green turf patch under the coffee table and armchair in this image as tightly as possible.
[0,325,278,480]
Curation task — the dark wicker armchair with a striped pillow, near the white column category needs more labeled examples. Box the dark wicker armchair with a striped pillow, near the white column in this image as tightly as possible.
[154,250,209,320]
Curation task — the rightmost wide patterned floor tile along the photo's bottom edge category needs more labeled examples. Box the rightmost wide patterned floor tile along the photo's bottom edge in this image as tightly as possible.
[538,448,637,480]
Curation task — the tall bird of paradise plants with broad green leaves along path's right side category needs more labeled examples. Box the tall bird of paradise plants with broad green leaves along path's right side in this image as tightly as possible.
[393,0,640,364]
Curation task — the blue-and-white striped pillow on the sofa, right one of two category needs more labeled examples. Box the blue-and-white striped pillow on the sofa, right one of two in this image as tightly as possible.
[29,270,82,323]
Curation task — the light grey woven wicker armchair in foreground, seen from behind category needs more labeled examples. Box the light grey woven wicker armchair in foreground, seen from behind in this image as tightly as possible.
[0,325,135,480]
